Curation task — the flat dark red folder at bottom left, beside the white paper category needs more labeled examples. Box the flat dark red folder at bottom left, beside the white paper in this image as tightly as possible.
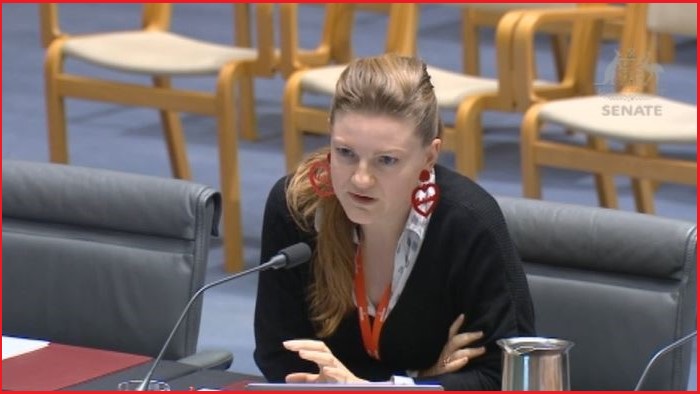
[2,343,151,391]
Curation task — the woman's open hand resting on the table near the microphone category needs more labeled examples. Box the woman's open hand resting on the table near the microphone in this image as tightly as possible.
[282,339,367,383]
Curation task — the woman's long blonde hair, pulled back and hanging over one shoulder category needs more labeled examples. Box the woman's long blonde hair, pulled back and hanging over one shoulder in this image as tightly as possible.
[286,54,442,338]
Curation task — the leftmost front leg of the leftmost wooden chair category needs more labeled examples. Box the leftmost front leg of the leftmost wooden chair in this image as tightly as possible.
[44,42,68,164]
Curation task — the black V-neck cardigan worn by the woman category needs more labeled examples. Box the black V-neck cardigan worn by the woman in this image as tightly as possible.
[254,166,534,390]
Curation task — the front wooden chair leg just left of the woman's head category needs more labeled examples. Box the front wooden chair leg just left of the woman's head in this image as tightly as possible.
[282,73,304,172]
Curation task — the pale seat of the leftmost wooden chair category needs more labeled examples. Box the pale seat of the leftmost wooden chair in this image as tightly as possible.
[63,31,258,76]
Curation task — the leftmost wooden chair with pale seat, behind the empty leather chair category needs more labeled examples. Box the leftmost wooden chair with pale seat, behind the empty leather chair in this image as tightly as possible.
[40,3,276,271]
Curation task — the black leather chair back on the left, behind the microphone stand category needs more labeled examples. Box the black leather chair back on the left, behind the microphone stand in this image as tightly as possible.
[2,160,221,359]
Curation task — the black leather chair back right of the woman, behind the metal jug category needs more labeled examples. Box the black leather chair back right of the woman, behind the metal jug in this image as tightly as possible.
[498,198,697,390]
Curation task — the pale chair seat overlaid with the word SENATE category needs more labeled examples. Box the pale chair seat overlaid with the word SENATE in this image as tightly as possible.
[539,94,698,144]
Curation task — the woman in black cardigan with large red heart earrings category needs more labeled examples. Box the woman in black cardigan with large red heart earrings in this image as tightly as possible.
[255,55,534,390]
